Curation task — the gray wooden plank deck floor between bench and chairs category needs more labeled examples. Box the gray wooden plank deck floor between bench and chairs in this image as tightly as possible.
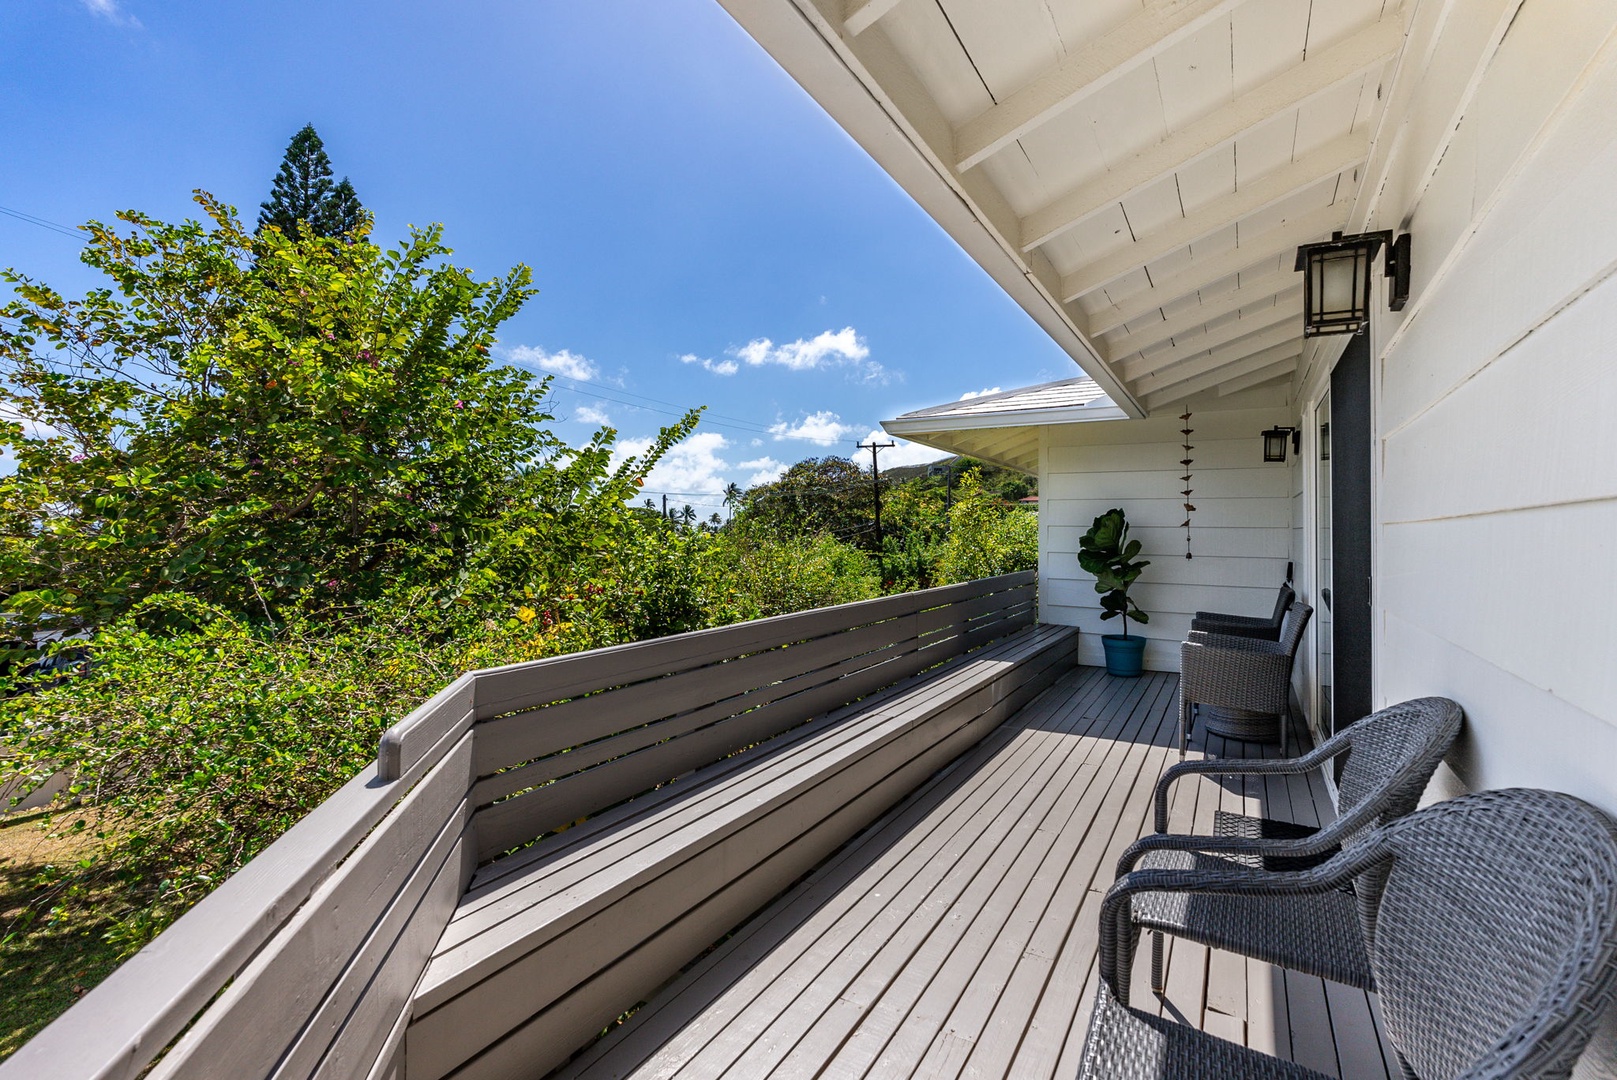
[556,668,1399,1080]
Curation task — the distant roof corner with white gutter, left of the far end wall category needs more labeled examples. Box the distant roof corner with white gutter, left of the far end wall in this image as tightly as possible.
[881,378,1129,472]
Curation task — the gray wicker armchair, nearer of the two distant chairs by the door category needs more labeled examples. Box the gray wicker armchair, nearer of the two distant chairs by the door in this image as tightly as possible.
[1179,601,1313,758]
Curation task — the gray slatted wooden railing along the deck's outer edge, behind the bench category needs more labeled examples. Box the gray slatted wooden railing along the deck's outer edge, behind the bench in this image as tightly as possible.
[0,572,1033,1080]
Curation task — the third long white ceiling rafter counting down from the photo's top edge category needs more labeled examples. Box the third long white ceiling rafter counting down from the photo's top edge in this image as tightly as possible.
[1061,128,1370,301]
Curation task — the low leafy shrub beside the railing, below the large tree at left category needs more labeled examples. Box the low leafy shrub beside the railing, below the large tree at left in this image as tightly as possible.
[0,592,601,952]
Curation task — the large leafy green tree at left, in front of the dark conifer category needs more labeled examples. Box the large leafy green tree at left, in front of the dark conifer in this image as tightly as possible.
[0,192,695,624]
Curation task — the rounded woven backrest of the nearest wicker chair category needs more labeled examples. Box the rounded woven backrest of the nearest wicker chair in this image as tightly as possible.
[1357,789,1617,1080]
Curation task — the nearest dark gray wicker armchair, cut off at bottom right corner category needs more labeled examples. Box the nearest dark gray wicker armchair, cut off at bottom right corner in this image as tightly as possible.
[1079,789,1617,1080]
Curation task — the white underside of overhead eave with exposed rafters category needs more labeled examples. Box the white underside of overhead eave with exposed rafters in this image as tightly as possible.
[720,0,1405,416]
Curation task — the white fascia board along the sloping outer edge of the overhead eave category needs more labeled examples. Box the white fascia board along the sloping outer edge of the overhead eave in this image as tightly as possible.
[720,0,1145,419]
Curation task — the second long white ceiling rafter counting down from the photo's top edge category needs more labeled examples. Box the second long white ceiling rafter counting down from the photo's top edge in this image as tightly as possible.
[1022,18,1404,251]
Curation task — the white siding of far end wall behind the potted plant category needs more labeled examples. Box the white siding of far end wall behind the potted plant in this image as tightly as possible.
[1038,404,1297,671]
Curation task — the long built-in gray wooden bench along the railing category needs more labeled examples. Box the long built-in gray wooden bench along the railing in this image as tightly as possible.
[406,626,1077,1080]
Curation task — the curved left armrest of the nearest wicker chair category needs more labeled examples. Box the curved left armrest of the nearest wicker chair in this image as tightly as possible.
[1100,836,1391,1004]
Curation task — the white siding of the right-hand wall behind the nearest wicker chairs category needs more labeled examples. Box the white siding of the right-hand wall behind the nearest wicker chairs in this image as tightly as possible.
[1305,0,1617,813]
